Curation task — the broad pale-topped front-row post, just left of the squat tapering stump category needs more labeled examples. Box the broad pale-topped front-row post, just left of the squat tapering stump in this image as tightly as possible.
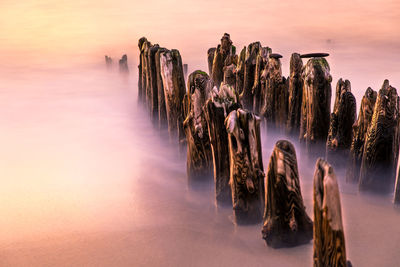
[225,109,264,224]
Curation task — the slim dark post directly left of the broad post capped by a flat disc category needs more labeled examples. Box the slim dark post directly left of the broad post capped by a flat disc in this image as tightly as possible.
[286,53,303,136]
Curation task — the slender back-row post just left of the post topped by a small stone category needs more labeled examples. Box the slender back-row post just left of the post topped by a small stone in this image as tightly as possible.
[252,47,271,115]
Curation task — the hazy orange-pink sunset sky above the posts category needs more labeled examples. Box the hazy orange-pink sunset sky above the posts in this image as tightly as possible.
[0,0,400,99]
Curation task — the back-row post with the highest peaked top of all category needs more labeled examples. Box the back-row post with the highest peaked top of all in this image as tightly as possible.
[211,33,232,88]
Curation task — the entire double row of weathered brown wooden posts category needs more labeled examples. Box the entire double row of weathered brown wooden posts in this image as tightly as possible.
[138,34,400,266]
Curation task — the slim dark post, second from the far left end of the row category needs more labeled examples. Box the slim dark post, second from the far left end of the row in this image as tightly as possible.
[147,44,160,123]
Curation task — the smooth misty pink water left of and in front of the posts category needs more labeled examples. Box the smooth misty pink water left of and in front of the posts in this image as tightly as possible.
[0,64,400,266]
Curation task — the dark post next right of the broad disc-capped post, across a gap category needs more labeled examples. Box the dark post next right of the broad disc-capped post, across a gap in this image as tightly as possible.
[326,79,356,168]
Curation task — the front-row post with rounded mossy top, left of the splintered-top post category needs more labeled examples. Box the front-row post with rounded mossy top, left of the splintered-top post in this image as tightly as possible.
[183,70,212,186]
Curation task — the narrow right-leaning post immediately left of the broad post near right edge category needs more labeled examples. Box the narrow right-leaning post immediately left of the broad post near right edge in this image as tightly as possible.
[346,87,376,183]
